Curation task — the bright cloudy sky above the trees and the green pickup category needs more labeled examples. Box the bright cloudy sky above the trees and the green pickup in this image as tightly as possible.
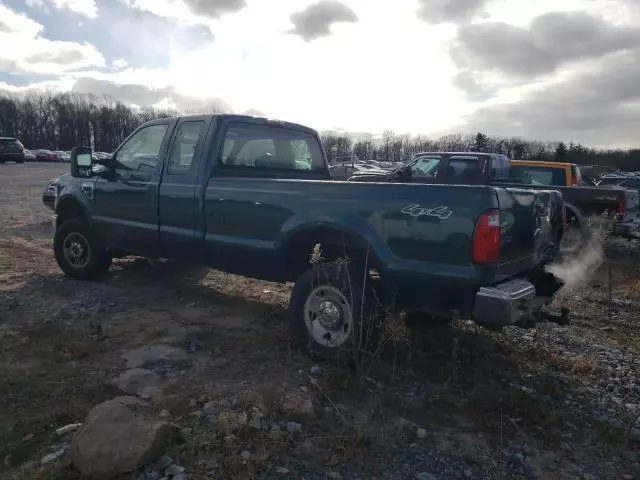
[0,0,640,147]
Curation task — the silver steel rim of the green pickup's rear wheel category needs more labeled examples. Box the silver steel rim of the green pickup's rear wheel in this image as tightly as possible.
[304,285,353,348]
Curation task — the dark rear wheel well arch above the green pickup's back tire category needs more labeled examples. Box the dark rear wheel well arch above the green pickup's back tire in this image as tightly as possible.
[284,228,381,281]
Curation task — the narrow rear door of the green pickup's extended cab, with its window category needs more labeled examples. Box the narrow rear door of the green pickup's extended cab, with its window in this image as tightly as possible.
[158,116,211,260]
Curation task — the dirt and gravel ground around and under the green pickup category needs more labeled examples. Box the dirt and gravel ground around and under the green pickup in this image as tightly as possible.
[0,164,640,480]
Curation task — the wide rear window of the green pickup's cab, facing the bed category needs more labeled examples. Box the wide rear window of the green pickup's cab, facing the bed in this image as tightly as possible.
[220,123,326,172]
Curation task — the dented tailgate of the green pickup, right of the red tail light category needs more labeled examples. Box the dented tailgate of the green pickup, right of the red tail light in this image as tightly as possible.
[496,188,564,276]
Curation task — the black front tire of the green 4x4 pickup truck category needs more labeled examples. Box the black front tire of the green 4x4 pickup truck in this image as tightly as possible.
[53,218,112,280]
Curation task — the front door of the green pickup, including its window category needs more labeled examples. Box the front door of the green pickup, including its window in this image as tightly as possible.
[92,120,172,257]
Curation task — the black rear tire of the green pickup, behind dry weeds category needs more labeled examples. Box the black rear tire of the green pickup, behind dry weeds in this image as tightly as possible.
[289,262,381,365]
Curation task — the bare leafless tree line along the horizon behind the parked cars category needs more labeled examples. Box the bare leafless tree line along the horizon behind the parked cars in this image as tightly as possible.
[0,93,640,170]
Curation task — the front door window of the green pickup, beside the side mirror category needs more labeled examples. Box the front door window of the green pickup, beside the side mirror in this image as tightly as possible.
[115,124,169,171]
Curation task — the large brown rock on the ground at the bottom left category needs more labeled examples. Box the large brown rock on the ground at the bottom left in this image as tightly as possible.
[71,397,174,480]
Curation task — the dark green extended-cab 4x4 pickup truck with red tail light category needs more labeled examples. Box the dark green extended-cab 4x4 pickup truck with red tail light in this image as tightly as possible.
[43,115,562,357]
